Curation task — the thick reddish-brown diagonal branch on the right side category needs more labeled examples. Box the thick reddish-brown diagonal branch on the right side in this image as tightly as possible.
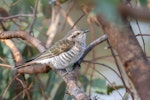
[93,15,150,100]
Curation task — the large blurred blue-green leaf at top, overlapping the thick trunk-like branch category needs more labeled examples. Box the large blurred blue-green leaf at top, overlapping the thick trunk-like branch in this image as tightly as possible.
[90,0,121,23]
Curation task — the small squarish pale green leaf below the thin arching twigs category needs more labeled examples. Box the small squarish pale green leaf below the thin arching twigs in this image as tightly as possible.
[92,78,107,94]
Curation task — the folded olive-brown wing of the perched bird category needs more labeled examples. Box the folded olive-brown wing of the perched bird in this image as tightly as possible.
[33,40,75,61]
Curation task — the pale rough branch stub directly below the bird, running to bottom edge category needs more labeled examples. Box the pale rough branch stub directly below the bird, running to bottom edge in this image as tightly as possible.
[56,67,90,100]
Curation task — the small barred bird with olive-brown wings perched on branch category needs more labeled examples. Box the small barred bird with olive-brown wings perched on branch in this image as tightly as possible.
[15,28,88,69]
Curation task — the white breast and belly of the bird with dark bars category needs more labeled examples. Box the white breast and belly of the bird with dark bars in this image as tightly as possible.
[50,44,85,69]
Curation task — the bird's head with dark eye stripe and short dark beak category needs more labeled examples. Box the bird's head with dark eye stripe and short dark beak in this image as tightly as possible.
[65,29,88,42]
